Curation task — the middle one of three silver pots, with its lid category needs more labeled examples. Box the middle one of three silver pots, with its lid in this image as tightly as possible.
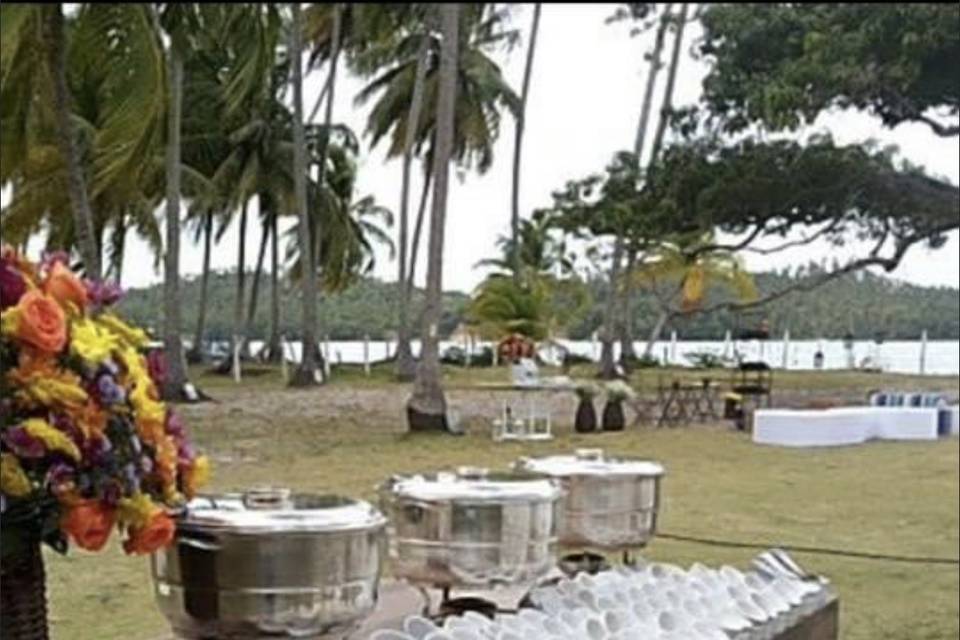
[381,469,560,588]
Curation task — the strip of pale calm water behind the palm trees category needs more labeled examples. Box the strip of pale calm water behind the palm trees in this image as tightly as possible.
[251,340,960,375]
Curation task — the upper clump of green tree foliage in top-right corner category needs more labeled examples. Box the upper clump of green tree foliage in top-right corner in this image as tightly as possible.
[700,3,960,135]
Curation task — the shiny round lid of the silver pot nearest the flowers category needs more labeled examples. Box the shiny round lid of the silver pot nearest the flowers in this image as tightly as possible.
[179,488,387,533]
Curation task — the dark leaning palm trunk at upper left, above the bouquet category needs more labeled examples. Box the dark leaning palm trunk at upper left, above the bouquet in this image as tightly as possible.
[44,2,100,280]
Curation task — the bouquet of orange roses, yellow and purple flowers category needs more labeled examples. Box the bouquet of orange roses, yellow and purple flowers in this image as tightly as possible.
[0,248,209,557]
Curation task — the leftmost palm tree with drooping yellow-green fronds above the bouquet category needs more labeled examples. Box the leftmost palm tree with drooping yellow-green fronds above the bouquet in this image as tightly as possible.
[0,3,166,277]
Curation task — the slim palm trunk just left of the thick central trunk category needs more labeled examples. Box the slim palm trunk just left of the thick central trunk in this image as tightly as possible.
[396,31,430,380]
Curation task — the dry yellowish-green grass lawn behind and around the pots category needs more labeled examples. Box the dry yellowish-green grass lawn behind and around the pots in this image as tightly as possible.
[46,364,960,640]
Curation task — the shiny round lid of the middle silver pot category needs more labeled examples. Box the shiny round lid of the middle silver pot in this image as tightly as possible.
[386,468,561,503]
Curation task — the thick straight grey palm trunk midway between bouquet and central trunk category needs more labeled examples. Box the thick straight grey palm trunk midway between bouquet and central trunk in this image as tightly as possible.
[290,2,332,386]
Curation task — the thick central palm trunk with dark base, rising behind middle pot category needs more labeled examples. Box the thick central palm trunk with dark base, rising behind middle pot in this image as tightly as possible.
[407,3,460,430]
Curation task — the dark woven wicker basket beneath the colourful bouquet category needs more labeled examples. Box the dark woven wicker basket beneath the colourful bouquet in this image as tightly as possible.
[0,542,50,640]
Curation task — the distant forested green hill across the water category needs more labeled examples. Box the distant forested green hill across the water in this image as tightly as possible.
[121,266,960,340]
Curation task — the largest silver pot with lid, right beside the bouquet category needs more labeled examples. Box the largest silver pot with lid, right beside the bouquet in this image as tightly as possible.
[151,490,386,639]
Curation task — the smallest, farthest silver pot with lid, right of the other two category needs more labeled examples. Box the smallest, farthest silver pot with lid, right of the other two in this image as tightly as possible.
[514,449,664,550]
